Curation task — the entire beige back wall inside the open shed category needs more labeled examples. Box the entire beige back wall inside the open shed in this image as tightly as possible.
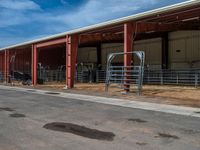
[75,31,200,69]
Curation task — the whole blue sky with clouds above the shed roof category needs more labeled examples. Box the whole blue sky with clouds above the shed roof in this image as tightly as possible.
[0,0,189,47]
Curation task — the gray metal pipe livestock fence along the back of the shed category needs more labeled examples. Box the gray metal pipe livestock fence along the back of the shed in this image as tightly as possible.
[76,69,200,87]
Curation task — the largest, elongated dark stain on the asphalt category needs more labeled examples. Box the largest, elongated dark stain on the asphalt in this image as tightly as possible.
[43,122,115,141]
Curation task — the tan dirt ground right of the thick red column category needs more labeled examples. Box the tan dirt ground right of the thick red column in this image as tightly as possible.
[74,84,200,107]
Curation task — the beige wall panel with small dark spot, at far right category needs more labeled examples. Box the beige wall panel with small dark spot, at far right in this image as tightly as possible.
[169,31,200,69]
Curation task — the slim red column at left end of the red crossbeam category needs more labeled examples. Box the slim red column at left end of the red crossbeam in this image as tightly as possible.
[32,44,38,86]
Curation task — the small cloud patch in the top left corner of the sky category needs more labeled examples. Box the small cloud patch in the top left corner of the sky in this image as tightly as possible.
[0,0,40,11]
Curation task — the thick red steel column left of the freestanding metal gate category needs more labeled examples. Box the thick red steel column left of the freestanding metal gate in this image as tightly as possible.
[66,35,78,88]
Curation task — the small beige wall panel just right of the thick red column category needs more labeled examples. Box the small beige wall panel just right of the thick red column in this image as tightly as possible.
[77,47,97,63]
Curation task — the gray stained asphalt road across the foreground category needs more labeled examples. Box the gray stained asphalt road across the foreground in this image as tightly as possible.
[0,89,200,150]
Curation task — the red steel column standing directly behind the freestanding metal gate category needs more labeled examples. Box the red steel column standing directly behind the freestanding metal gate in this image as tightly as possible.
[124,23,135,92]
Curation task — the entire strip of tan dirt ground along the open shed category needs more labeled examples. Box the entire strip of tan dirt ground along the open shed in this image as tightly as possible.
[2,83,200,107]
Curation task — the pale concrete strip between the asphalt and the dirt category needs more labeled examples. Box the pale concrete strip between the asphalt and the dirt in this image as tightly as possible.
[0,85,200,118]
